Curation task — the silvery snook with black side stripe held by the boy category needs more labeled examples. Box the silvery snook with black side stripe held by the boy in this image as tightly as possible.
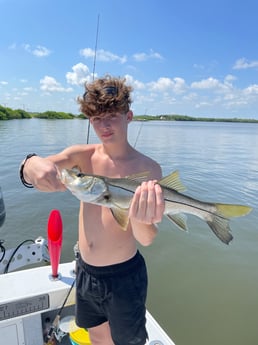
[60,169,252,244]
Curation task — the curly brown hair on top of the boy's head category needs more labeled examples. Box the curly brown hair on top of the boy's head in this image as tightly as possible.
[77,75,133,118]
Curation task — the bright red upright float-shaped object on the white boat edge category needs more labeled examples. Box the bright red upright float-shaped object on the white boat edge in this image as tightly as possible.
[47,210,63,278]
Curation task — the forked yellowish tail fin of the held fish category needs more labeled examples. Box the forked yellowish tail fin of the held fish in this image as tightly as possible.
[207,204,252,244]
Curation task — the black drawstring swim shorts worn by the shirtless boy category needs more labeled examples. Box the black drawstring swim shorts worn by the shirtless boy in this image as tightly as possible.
[76,252,148,345]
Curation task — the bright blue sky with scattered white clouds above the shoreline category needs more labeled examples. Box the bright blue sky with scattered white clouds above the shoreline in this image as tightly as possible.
[0,0,258,119]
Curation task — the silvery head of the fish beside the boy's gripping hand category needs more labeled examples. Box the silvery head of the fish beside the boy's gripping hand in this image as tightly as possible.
[60,169,107,203]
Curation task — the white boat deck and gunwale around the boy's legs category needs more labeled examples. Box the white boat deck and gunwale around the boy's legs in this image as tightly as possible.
[0,262,175,345]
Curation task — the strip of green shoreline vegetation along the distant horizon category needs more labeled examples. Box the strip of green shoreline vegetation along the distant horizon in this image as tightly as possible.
[0,105,258,123]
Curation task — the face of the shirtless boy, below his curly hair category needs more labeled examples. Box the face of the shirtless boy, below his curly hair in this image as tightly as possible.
[90,111,133,142]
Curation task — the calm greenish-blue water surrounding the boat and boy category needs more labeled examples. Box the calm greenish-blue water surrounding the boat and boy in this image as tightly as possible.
[0,119,258,345]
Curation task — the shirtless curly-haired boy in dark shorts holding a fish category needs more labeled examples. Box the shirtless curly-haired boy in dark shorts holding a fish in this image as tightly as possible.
[20,76,164,345]
